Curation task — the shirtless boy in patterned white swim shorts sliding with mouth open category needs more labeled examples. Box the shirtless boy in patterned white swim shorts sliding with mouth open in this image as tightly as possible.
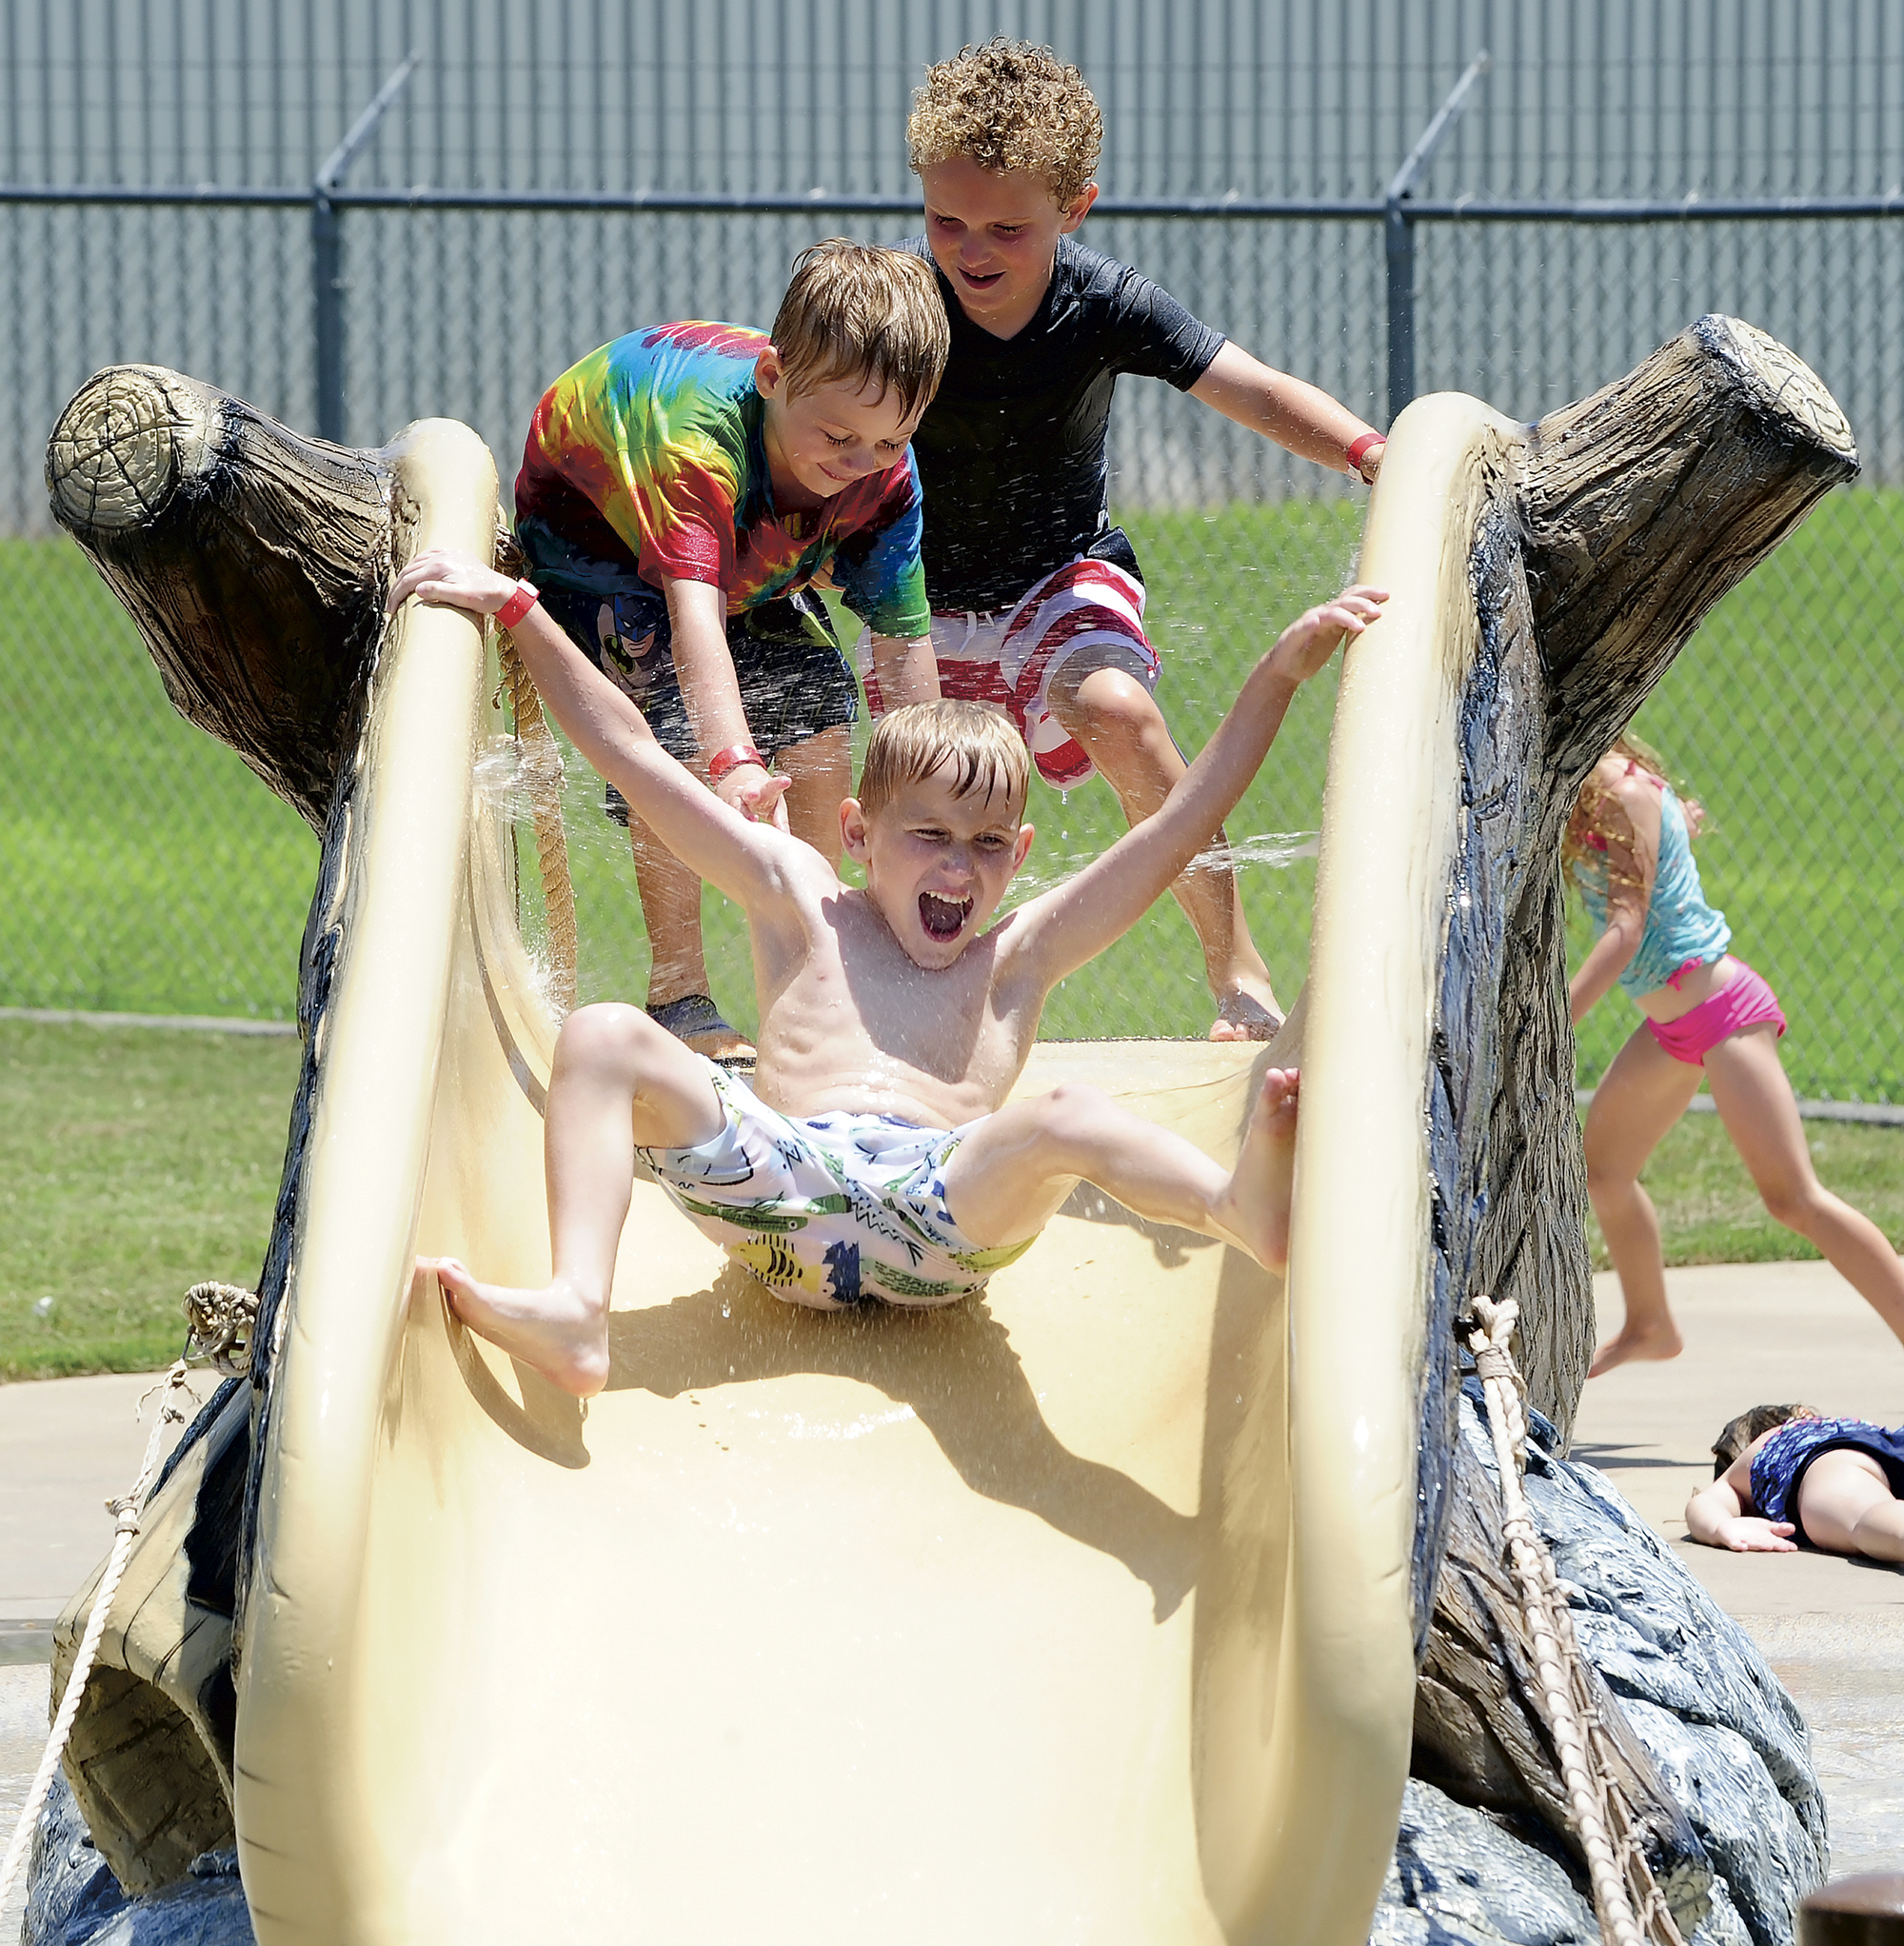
[389,552,1386,1398]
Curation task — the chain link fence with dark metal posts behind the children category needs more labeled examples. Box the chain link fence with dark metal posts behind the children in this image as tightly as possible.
[0,0,1904,1102]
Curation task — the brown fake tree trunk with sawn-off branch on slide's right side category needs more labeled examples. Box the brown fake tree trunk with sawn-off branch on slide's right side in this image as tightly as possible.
[1412,317,1857,1911]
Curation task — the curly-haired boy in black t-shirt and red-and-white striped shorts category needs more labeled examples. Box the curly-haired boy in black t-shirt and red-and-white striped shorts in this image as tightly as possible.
[891,39,1382,1042]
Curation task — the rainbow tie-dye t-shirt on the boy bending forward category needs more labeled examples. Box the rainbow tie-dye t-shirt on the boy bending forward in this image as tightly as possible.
[516,323,931,640]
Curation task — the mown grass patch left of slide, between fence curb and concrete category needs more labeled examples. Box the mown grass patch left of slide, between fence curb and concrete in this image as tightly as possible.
[0,1020,300,1380]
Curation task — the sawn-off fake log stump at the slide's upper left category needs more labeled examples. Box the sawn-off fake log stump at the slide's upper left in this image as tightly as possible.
[47,366,389,831]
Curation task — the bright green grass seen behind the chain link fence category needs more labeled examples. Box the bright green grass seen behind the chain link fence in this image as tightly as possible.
[0,490,1904,1102]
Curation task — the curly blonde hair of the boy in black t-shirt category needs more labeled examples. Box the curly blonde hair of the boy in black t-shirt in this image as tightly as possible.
[905,35,1104,208]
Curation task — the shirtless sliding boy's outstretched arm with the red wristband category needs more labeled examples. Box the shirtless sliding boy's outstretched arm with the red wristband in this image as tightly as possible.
[387,548,825,919]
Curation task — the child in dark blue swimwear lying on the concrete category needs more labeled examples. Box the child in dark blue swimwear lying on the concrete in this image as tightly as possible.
[1686,1405,1904,1560]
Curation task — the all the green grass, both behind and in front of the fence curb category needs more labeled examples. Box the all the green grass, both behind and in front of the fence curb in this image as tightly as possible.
[0,478,1904,1376]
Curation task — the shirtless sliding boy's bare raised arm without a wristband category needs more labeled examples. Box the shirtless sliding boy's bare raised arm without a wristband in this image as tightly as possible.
[1012,587,1388,992]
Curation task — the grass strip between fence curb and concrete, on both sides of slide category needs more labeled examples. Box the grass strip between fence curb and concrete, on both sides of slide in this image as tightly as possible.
[0,1020,1904,1380]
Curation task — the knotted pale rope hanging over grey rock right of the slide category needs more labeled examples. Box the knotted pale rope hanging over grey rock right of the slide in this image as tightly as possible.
[1468,1298,1684,1946]
